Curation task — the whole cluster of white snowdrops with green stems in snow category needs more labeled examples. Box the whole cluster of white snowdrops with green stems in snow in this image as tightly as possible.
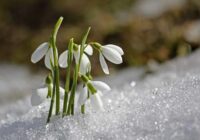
[31,17,124,123]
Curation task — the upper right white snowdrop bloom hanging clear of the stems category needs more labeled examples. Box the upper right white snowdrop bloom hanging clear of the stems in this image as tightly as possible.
[99,44,124,74]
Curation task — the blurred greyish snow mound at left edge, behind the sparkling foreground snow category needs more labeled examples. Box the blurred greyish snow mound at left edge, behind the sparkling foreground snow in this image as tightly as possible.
[0,64,44,105]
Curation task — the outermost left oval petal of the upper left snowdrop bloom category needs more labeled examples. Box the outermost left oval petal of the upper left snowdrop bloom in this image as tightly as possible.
[31,42,49,63]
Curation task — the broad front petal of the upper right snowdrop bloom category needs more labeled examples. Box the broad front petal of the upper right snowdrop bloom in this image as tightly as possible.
[102,46,122,64]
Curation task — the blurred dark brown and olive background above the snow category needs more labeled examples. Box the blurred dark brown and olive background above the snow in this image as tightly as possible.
[0,0,200,75]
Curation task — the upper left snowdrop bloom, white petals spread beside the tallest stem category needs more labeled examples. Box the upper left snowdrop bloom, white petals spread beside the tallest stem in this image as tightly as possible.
[31,42,54,69]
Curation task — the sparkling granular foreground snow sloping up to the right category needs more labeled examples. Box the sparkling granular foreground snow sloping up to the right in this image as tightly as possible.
[0,50,200,140]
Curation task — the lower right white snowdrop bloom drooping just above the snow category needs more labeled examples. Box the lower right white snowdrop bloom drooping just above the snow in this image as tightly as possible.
[78,81,111,110]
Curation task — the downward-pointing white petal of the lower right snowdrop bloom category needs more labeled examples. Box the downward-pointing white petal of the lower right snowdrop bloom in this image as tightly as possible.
[90,93,104,110]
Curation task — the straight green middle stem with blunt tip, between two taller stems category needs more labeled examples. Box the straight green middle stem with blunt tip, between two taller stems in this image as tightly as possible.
[62,38,73,117]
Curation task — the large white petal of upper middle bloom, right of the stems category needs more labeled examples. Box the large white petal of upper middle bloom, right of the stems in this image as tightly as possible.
[80,54,91,74]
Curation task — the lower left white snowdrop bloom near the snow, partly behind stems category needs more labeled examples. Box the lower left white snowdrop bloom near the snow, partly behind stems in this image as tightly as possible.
[31,84,65,106]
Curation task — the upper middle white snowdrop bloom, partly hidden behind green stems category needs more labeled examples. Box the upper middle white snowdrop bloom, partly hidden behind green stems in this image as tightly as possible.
[59,45,93,74]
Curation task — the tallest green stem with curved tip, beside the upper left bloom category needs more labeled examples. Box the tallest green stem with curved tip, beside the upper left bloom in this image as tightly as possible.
[51,17,63,115]
